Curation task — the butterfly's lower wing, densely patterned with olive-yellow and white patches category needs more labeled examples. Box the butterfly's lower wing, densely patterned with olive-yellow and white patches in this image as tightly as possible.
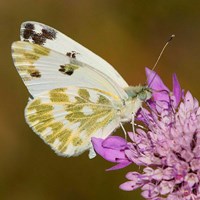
[25,86,122,157]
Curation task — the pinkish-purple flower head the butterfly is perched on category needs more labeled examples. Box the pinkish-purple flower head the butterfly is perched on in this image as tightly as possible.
[92,69,200,200]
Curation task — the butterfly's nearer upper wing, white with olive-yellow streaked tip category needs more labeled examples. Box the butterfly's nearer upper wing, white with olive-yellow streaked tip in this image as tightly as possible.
[12,41,127,98]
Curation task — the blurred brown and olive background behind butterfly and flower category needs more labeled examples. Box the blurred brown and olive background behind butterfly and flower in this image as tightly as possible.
[0,0,200,200]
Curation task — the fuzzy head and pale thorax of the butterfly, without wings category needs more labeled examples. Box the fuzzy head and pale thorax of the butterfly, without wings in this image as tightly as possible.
[117,85,152,121]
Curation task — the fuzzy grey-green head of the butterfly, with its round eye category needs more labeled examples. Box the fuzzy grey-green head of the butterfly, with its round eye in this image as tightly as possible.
[125,85,152,102]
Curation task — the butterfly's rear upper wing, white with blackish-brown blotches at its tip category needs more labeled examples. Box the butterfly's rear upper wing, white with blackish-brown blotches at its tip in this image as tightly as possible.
[20,21,128,88]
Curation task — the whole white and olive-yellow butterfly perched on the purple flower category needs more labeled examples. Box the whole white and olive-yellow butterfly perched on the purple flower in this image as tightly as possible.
[12,21,152,157]
